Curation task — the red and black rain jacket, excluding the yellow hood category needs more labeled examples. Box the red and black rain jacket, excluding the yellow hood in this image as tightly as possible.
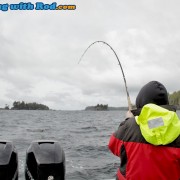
[109,118,180,180]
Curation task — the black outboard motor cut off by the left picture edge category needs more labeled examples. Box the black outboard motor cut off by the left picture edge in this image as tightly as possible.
[0,141,18,180]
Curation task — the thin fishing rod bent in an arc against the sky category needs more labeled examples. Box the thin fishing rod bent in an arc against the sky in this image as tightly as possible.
[78,41,132,111]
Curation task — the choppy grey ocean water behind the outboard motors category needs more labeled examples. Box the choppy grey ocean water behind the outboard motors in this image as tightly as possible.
[0,110,180,180]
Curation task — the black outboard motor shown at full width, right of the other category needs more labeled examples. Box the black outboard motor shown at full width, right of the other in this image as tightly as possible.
[25,141,65,180]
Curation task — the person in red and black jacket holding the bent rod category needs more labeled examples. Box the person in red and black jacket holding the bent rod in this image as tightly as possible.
[108,81,180,180]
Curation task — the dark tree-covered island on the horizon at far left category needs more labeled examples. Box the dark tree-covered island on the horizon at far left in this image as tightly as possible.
[4,101,49,110]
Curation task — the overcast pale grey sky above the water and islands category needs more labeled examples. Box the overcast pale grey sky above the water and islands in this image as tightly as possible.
[0,0,180,110]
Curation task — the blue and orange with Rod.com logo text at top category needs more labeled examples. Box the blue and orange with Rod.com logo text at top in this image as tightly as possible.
[0,2,76,11]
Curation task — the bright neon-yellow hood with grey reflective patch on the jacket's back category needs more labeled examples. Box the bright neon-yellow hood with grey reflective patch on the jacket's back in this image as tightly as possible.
[135,104,180,145]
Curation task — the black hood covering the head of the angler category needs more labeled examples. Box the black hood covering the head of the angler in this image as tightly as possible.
[136,81,169,108]
